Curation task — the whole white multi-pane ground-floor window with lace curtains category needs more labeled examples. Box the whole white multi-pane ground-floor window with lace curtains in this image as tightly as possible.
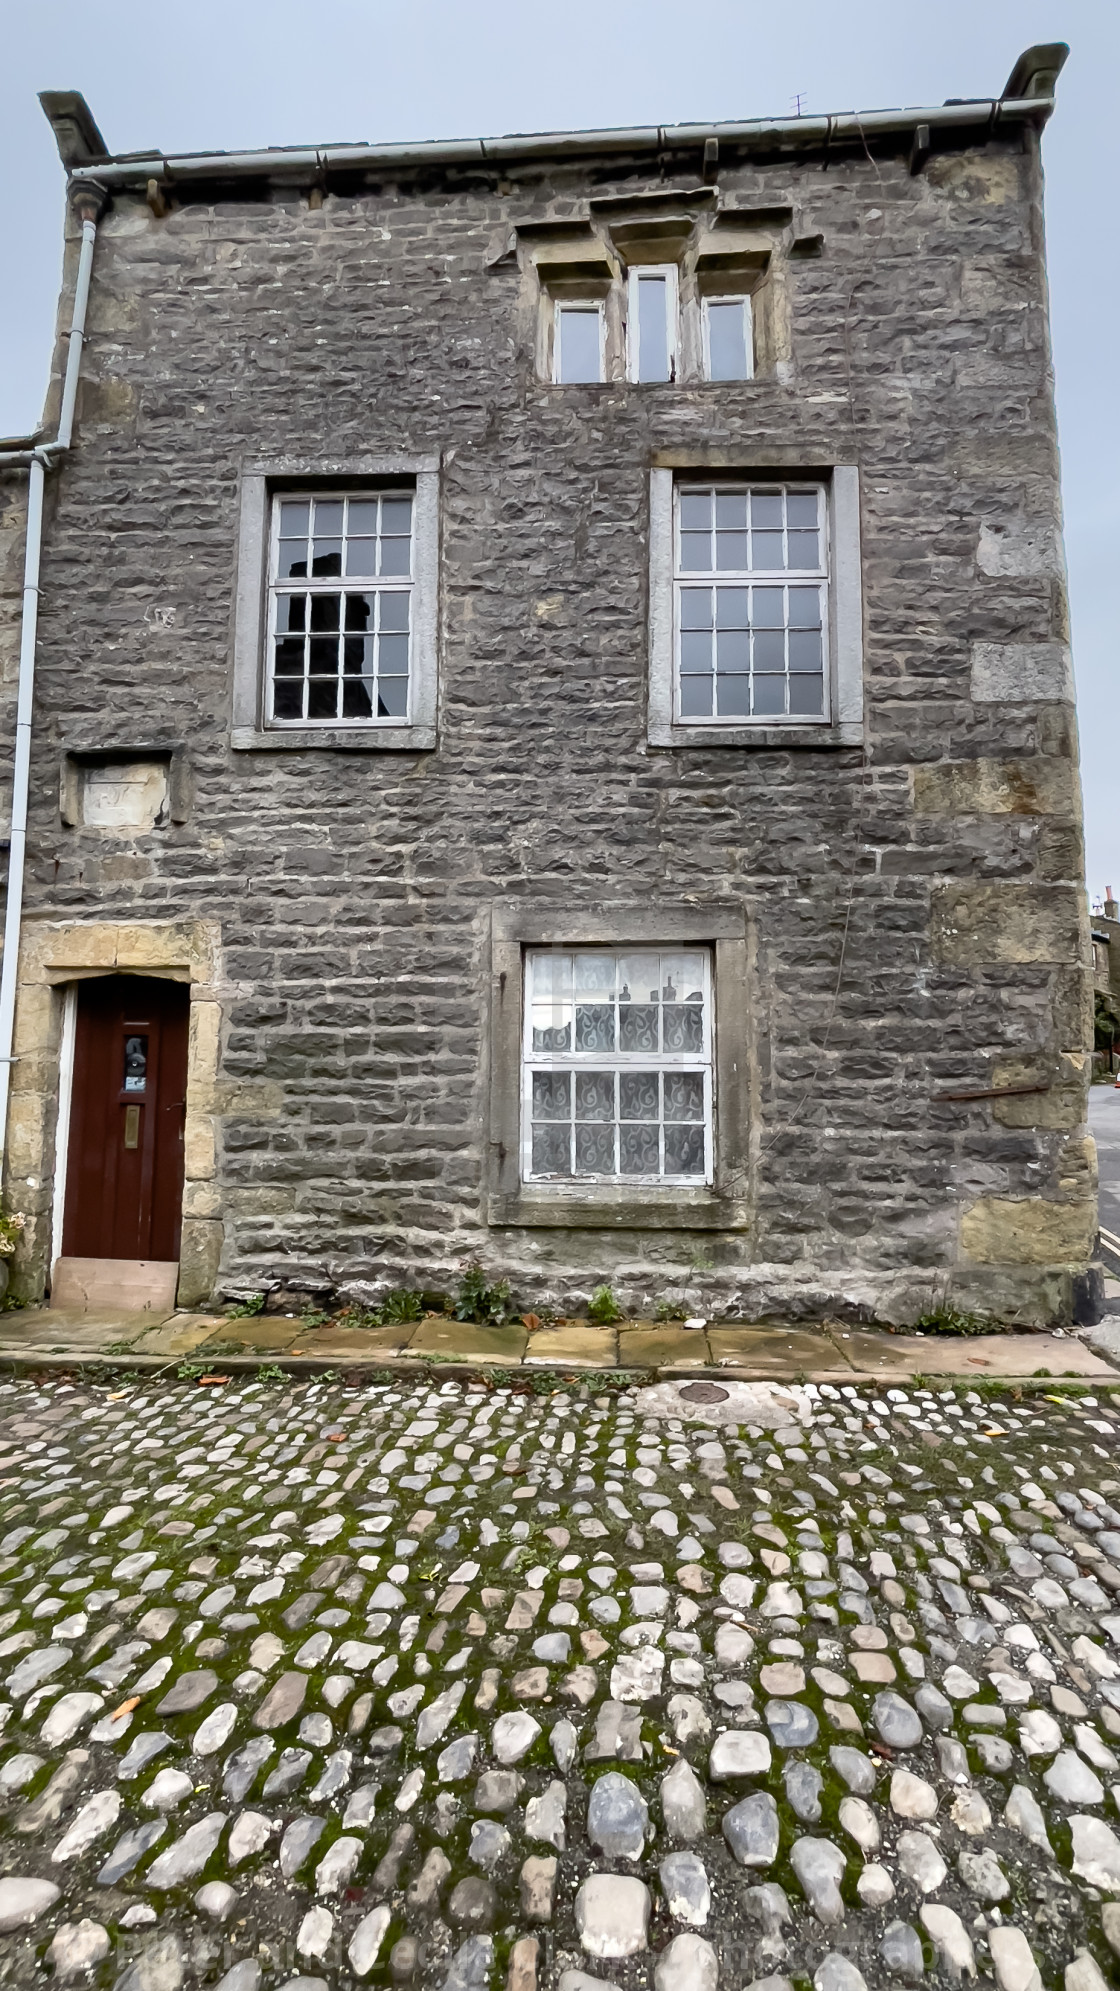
[521,948,712,1185]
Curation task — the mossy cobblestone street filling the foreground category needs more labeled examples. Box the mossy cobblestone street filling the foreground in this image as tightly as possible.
[0,1378,1120,1991]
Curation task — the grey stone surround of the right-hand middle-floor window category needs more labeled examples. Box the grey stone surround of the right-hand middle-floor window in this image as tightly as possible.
[647,465,863,749]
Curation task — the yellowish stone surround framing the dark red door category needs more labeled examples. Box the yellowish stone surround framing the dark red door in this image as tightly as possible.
[4,920,225,1306]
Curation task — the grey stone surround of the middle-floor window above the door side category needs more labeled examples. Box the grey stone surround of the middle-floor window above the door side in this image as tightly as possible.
[231,454,440,753]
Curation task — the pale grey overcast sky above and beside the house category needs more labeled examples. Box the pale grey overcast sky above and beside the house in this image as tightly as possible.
[0,0,1120,894]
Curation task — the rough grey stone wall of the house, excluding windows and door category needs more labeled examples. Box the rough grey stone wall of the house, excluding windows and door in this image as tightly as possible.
[0,46,1096,1322]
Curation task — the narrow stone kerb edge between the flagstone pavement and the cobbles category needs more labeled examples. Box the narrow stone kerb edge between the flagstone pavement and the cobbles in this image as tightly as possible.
[0,1352,1120,1396]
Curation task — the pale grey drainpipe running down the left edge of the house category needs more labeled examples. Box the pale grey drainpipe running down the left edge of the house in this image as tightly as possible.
[0,181,105,1161]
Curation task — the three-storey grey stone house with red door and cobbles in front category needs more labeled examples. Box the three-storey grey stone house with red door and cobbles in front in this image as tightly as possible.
[0,46,1096,1320]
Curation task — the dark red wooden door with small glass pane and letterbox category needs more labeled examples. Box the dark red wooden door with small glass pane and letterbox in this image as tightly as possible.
[62,976,191,1260]
